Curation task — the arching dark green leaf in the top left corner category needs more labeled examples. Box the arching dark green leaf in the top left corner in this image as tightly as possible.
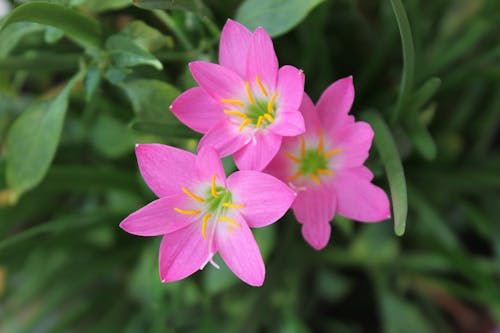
[0,2,101,48]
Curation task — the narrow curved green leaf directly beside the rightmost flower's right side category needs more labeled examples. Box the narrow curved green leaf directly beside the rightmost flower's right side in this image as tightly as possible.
[363,111,408,236]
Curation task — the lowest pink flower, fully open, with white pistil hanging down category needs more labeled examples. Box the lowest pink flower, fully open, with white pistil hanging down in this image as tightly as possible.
[120,144,294,286]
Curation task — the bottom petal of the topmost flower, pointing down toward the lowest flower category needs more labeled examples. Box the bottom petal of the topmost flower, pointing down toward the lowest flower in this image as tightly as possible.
[233,131,281,171]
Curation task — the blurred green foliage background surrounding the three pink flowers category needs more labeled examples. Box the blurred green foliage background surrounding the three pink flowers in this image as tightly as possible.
[0,0,500,333]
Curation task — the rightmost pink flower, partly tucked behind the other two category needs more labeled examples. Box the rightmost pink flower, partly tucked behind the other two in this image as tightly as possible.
[265,77,390,250]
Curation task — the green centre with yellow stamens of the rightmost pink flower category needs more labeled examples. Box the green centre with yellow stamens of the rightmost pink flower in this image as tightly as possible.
[284,132,342,185]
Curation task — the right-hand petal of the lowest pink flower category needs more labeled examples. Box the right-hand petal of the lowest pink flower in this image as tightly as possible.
[227,171,295,228]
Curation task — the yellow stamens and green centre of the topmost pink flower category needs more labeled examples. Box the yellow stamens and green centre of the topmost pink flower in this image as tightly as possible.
[221,75,278,132]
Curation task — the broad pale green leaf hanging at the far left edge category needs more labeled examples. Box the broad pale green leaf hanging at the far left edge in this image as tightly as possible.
[6,71,84,197]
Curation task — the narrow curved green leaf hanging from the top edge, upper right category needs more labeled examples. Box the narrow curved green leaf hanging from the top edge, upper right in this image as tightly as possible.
[391,0,415,121]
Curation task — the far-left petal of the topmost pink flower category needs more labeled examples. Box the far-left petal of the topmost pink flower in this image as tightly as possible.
[170,87,224,133]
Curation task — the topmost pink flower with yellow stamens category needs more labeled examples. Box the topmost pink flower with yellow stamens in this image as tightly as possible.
[170,20,304,170]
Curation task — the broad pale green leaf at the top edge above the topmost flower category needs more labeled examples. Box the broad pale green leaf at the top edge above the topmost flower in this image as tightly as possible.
[236,0,324,37]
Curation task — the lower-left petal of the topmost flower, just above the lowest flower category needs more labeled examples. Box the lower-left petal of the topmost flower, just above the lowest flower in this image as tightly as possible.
[198,119,248,157]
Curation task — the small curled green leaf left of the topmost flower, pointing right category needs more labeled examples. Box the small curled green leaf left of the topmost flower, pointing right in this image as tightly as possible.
[106,34,163,70]
